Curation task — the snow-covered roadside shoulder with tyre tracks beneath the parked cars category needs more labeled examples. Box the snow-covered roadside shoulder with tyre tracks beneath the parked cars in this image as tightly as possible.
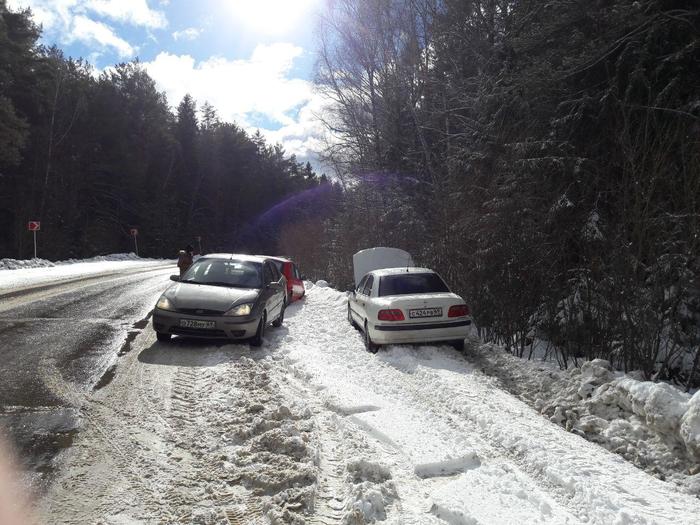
[40,287,700,524]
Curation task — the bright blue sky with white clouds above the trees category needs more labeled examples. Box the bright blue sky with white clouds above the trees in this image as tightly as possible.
[8,0,324,163]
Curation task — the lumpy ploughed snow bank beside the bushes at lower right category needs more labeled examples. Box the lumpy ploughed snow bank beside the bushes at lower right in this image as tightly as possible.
[472,345,700,495]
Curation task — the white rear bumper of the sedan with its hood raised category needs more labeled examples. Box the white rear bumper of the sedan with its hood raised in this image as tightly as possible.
[369,319,471,345]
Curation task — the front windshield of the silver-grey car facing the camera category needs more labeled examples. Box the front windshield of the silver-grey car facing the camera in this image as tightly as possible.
[181,259,262,288]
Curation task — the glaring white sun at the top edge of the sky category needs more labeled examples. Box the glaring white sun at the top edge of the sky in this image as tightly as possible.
[228,0,320,35]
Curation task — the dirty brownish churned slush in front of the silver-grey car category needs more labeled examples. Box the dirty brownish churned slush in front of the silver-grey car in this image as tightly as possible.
[41,331,318,524]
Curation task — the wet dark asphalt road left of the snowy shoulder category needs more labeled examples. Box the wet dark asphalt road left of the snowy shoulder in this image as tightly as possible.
[0,265,176,491]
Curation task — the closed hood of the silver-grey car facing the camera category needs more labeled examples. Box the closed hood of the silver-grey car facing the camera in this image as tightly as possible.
[164,283,260,312]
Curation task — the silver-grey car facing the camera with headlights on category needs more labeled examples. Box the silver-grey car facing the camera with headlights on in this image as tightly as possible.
[153,254,287,346]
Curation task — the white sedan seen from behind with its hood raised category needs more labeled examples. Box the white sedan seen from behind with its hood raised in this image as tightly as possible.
[348,268,472,352]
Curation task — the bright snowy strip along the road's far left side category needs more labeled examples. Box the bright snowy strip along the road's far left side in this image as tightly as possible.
[0,253,174,295]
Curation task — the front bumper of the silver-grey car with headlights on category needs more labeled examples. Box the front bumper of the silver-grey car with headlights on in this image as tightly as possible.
[153,308,260,339]
